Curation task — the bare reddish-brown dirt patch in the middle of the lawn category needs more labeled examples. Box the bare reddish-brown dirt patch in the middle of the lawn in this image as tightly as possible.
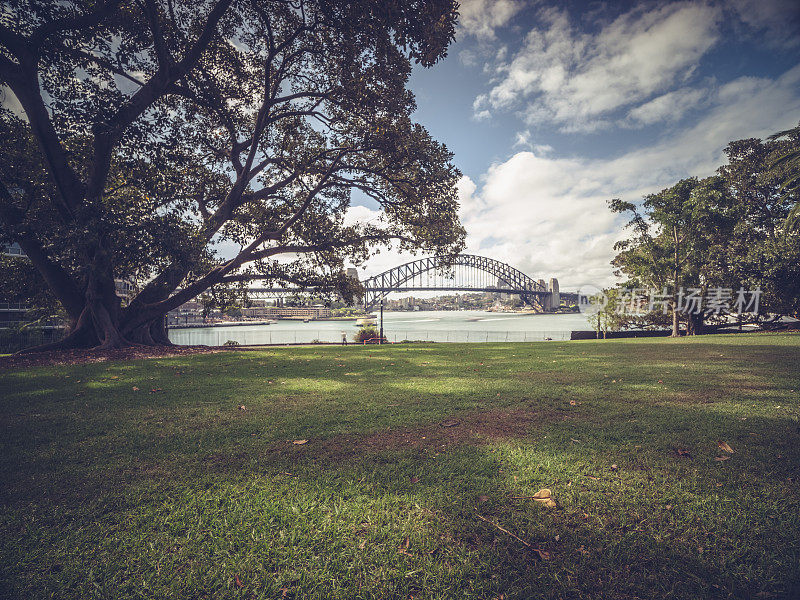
[280,408,569,458]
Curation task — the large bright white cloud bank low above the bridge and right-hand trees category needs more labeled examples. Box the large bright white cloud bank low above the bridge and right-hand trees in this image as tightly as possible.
[450,66,800,289]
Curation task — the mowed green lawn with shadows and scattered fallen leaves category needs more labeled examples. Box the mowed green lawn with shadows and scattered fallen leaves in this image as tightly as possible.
[0,334,800,599]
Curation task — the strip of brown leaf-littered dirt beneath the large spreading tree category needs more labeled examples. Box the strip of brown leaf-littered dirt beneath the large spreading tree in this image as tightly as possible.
[0,346,229,371]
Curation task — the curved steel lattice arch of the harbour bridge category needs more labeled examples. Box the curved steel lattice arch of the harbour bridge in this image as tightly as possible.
[361,254,548,310]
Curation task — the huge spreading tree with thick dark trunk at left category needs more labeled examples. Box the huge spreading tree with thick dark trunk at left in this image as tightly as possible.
[0,0,464,346]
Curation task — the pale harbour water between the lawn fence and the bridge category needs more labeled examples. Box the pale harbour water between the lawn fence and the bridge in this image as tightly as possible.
[169,311,591,346]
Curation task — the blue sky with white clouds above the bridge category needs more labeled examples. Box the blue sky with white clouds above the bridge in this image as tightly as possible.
[351,0,800,289]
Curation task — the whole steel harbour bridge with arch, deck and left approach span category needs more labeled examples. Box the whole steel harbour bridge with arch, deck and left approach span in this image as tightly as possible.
[248,254,578,311]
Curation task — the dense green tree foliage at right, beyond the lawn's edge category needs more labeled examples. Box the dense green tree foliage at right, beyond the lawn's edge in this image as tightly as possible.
[609,129,800,335]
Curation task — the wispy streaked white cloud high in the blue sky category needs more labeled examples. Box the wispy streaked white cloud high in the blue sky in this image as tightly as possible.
[475,2,722,131]
